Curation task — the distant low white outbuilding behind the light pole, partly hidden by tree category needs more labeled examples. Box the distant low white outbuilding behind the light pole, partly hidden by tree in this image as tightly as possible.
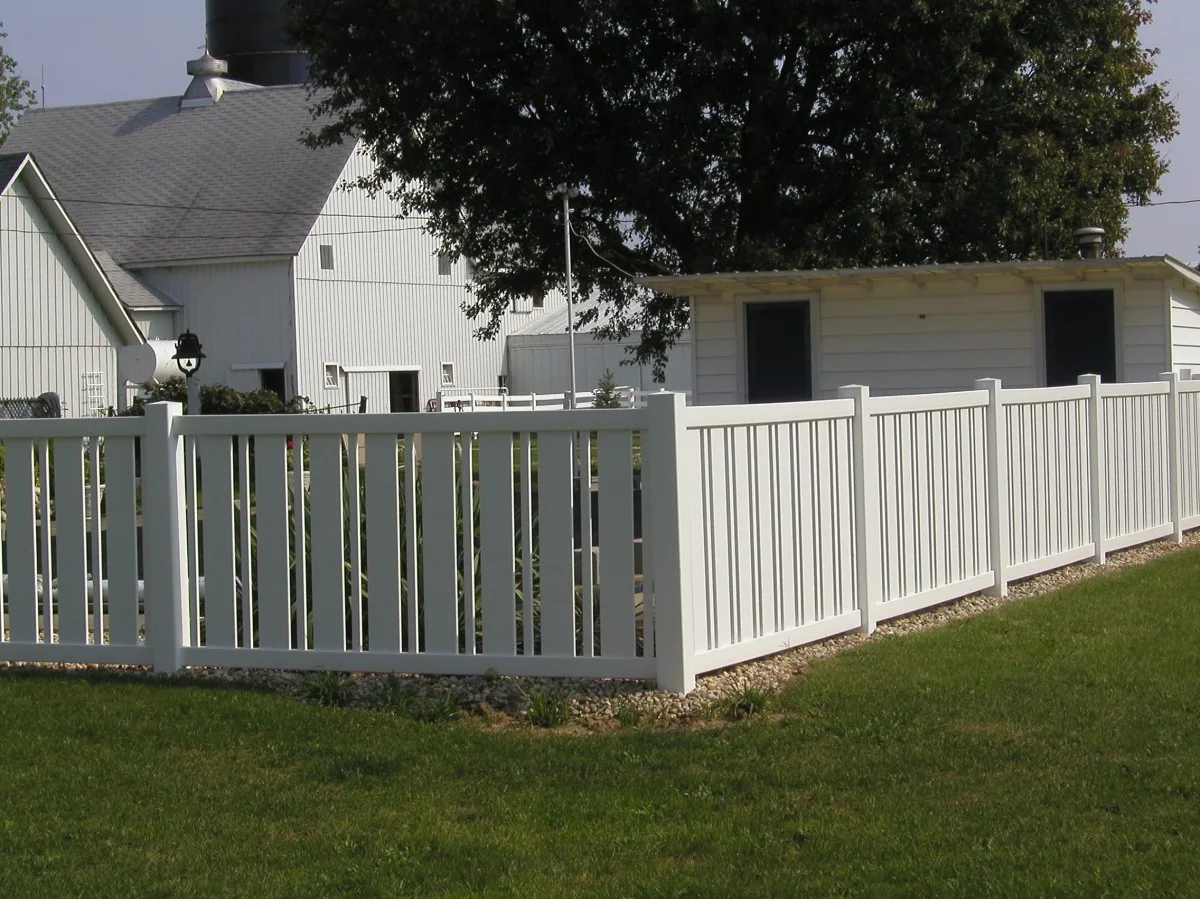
[506,306,692,396]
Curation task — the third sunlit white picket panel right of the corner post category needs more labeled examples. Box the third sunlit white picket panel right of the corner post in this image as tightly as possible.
[1002,386,1094,579]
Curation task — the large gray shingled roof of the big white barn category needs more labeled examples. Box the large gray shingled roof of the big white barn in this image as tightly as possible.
[4,86,354,266]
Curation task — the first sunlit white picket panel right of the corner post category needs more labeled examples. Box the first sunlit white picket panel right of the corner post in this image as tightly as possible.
[681,400,859,672]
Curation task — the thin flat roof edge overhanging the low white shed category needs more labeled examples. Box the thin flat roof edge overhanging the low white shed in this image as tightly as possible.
[638,256,1200,296]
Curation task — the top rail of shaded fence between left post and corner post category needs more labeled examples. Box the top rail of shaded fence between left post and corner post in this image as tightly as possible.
[175,409,649,437]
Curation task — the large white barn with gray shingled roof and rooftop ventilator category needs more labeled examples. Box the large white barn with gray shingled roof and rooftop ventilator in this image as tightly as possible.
[6,56,557,412]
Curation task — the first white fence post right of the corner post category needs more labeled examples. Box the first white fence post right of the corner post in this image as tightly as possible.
[838,384,882,634]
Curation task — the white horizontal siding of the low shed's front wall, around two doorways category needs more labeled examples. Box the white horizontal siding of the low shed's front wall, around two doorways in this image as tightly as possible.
[692,268,1176,404]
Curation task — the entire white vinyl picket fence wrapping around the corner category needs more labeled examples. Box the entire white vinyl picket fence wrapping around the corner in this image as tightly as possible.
[0,376,1200,691]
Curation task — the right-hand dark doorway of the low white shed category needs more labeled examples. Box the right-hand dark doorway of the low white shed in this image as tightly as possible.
[1043,290,1117,386]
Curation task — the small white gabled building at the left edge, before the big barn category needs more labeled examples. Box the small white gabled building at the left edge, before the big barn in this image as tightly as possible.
[0,152,142,416]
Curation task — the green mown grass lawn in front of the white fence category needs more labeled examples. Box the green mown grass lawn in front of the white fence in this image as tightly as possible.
[0,551,1200,897]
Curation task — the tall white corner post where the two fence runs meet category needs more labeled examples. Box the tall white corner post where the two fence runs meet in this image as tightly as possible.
[642,394,698,693]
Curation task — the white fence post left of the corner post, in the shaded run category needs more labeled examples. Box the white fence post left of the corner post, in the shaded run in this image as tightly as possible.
[142,402,191,671]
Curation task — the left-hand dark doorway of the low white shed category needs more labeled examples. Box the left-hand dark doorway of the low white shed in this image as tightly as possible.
[746,302,812,402]
